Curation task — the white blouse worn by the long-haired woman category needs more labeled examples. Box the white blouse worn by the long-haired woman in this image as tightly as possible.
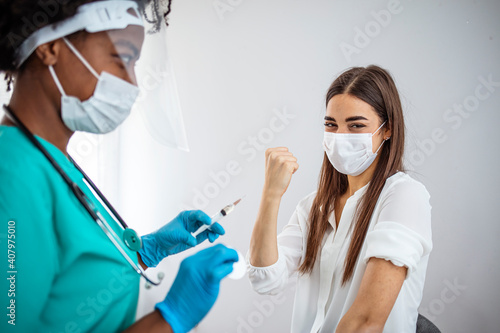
[247,172,432,333]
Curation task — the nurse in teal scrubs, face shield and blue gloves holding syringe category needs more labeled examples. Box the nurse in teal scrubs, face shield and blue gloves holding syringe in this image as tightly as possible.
[0,0,238,333]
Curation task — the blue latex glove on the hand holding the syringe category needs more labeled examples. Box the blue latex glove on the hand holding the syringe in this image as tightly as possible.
[139,210,225,267]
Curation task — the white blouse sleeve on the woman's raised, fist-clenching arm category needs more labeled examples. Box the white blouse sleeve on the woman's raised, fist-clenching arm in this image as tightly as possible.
[246,192,316,295]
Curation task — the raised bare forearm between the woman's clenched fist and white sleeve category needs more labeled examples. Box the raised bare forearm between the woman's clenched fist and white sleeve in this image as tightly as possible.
[250,190,281,267]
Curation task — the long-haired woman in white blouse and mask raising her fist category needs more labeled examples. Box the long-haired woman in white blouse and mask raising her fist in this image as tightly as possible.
[248,66,432,333]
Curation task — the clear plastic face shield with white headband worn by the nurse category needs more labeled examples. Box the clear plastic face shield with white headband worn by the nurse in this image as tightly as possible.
[16,0,189,151]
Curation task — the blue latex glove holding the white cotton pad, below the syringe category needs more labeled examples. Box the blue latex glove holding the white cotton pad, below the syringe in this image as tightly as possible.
[156,244,238,333]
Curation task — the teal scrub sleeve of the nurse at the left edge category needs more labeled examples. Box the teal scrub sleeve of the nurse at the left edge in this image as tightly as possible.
[0,126,59,332]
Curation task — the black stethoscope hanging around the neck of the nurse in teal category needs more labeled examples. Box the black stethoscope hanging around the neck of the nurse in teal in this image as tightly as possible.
[3,105,163,288]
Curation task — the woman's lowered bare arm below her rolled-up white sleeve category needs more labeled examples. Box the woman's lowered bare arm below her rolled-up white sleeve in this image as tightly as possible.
[336,257,407,332]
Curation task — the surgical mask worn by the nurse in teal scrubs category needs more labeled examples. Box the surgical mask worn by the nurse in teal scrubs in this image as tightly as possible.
[49,38,139,134]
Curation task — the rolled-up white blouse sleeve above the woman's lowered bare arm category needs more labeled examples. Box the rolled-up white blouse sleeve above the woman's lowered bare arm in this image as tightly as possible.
[363,172,433,279]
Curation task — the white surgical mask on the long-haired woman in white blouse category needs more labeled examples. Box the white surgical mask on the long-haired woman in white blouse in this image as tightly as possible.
[323,121,385,176]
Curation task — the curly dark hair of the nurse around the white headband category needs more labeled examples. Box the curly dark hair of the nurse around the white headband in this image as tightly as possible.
[0,0,172,90]
